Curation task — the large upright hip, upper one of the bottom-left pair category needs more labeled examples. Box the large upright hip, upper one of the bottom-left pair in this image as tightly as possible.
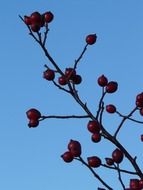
[68,140,81,157]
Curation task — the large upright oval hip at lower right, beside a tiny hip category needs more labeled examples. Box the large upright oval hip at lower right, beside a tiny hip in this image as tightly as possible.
[112,148,124,164]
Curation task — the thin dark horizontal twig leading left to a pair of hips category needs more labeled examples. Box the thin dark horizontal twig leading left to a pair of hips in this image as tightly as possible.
[40,115,89,121]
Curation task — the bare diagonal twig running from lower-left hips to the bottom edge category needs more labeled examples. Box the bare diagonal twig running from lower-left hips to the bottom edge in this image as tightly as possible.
[76,157,113,190]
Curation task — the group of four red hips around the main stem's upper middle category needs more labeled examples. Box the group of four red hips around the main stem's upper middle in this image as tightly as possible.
[43,68,82,86]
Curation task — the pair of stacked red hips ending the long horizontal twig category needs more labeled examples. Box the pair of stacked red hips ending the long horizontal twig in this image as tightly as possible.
[26,108,41,128]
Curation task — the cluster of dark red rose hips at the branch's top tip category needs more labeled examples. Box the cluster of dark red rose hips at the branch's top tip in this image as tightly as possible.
[24,11,54,32]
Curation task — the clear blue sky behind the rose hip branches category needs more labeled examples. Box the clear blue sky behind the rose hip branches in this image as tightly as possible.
[0,0,143,190]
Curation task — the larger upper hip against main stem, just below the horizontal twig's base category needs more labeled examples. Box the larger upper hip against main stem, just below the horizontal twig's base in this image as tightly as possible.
[87,120,101,133]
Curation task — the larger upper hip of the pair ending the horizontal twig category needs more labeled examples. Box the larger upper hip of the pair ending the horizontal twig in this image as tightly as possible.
[26,108,41,120]
